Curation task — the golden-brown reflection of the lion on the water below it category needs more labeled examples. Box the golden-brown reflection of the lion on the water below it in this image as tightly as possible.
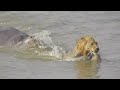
[75,60,101,79]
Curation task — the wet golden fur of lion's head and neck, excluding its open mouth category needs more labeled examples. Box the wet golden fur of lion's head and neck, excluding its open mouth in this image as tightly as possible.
[64,35,98,58]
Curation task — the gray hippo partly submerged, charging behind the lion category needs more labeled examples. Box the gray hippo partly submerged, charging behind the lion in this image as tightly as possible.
[0,26,40,48]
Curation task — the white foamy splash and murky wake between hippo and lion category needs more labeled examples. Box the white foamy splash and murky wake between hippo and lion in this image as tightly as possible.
[0,30,99,61]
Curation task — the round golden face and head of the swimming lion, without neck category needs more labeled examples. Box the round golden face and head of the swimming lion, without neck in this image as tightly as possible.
[76,35,99,59]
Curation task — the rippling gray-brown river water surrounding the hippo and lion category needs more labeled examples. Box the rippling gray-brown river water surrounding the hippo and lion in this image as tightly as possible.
[0,11,120,79]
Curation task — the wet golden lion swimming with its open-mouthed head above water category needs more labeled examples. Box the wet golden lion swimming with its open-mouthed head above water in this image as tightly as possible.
[64,35,99,60]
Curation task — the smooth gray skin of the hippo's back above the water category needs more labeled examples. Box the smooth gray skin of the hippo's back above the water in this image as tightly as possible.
[0,26,29,46]
